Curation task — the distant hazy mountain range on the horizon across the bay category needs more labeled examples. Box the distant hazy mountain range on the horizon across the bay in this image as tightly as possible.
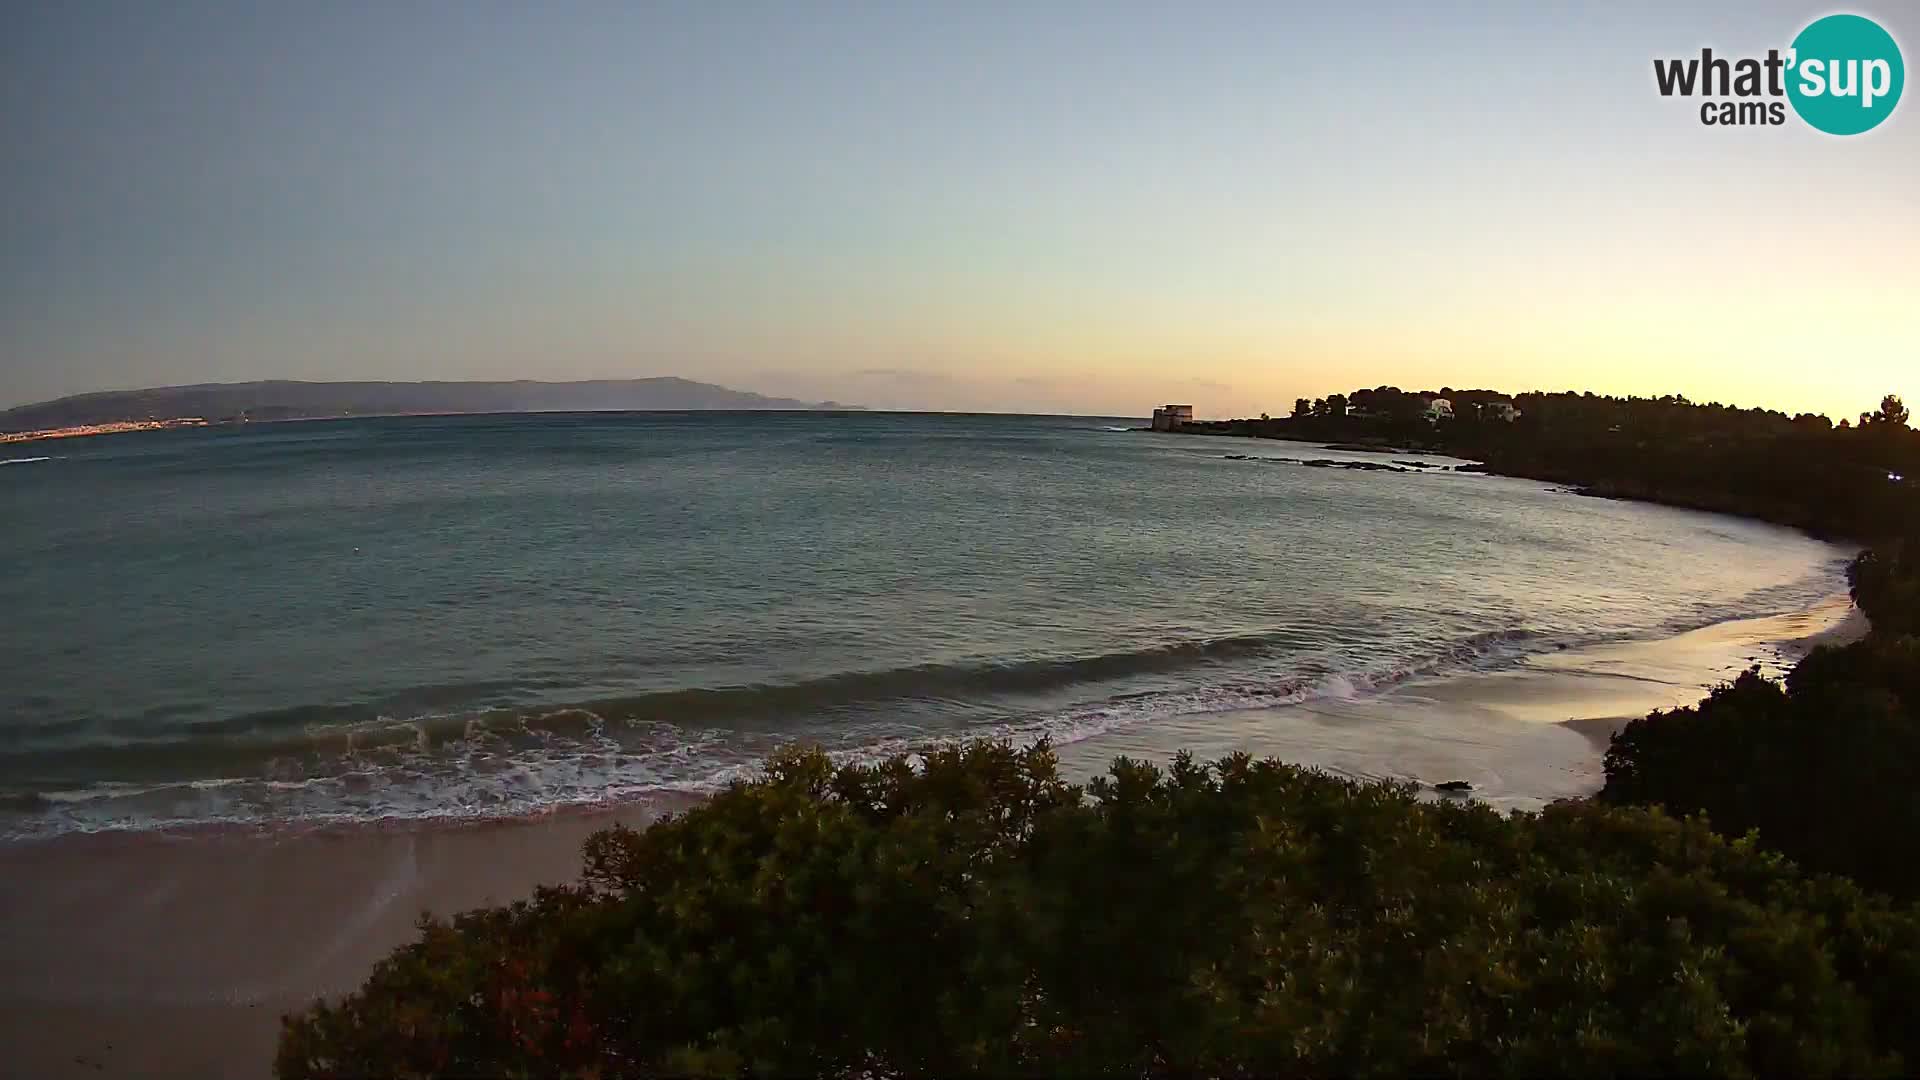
[0,379,858,430]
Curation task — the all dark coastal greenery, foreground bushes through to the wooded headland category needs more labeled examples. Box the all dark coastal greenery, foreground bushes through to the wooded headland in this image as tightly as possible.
[276,392,1920,1078]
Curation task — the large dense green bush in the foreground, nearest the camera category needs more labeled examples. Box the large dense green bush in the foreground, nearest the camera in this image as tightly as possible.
[278,744,1920,1078]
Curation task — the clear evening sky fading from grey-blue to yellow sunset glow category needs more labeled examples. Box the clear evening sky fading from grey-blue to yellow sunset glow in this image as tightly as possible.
[0,0,1920,419]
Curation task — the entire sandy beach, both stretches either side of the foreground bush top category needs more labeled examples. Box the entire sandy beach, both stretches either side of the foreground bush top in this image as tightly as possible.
[0,596,1864,1080]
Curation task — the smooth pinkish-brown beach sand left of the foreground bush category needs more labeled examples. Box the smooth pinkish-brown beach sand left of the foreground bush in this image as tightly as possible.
[0,799,691,1078]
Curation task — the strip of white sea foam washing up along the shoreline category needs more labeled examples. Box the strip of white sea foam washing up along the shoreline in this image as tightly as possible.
[0,632,1536,836]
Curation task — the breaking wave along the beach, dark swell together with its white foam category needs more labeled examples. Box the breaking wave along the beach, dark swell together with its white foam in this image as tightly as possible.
[0,628,1540,836]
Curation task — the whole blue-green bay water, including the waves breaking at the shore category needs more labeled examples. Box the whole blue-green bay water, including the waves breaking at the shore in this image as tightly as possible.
[0,413,1839,834]
